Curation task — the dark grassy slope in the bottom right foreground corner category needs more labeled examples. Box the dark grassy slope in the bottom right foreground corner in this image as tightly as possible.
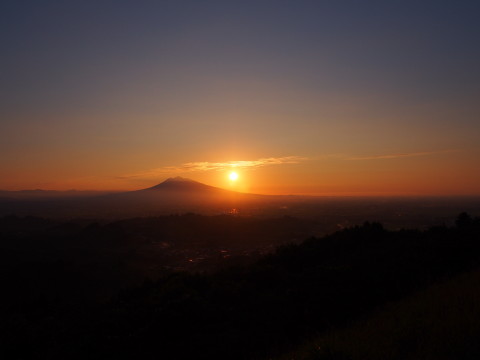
[285,270,480,360]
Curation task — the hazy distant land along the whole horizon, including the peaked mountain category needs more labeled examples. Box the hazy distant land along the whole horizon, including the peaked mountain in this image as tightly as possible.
[0,177,480,224]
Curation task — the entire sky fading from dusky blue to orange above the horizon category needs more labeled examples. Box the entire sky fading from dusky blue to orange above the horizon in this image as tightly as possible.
[0,0,480,195]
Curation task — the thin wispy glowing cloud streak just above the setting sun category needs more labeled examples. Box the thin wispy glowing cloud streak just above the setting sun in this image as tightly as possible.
[119,156,307,179]
